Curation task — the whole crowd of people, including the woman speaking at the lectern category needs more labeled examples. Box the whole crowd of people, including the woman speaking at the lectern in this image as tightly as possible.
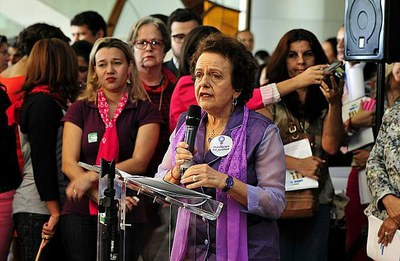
[0,5,400,261]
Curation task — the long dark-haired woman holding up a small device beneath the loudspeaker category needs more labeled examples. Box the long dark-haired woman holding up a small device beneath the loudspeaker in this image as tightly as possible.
[268,29,344,260]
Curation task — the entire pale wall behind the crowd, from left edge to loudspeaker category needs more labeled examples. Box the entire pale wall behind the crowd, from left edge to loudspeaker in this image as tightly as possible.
[0,0,345,52]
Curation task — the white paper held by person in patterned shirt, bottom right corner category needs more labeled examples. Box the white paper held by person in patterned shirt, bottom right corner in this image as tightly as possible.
[367,215,400,261]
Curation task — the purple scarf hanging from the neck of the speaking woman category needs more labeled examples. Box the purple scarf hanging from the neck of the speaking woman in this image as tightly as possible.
[171,106,249,261]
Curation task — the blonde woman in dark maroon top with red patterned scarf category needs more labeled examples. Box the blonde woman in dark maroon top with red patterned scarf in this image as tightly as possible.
[61,37,163,261]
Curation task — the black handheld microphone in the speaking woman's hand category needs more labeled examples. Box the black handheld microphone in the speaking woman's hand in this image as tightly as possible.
[180,105,201,175]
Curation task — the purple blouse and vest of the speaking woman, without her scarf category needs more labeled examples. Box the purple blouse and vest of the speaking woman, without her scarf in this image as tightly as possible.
[156,108,286,260]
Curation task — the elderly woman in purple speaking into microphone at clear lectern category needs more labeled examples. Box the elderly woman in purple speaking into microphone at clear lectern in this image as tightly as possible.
[156,35,286,260]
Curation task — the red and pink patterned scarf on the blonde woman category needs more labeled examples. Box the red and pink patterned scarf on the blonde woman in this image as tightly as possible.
[89,88,128,215]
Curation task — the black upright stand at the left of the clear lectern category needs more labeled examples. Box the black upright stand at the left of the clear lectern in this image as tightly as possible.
[99,159,120,261]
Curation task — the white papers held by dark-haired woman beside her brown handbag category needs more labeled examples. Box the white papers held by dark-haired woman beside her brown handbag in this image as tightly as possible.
[283,139,318,191]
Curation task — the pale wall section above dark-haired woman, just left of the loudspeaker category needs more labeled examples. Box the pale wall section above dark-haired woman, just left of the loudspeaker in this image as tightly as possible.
[250,0,345,53]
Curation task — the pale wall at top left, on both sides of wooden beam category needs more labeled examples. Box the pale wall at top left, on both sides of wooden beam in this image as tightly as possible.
[0,0,183,40]
